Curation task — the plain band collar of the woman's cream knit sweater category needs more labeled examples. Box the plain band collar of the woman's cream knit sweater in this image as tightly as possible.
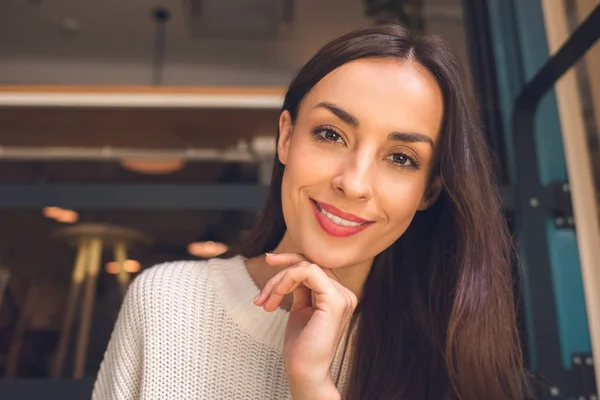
[209,256,289,351]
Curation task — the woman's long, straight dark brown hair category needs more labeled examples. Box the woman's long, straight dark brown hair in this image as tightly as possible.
[230,25,526,400]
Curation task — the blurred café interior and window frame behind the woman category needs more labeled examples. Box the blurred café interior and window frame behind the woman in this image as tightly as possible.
[0,0,600,400]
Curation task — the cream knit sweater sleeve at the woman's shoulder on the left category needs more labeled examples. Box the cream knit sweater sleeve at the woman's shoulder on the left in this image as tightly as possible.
[92,274,146,400]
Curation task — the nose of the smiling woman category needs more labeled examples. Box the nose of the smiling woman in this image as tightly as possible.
[331,152,374,201]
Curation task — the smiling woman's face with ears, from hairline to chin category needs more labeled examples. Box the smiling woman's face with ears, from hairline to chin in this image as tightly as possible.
[278,59,443,268]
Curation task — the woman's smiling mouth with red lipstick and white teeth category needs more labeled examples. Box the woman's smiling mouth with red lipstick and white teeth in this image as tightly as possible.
[311,199,373,237]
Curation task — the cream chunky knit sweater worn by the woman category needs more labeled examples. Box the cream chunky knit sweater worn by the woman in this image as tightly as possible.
[92,257,348,400]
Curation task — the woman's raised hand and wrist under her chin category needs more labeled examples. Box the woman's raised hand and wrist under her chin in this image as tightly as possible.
[255,254,358,398]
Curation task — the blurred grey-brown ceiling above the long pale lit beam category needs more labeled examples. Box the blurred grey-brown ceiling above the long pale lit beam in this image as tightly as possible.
[0,0,466,86]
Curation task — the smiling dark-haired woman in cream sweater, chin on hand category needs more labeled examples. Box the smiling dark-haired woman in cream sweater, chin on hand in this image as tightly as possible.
[94,26,525,400]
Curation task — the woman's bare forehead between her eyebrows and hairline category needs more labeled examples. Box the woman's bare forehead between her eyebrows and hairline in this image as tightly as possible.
[300,59,444,141]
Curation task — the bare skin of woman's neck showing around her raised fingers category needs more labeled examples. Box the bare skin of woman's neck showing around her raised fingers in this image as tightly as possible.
[248,232,373,299]
